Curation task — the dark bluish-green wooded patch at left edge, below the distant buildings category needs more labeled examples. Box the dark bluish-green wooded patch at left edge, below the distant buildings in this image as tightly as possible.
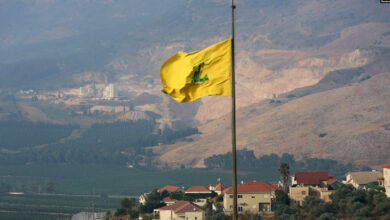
[0,121,78,150]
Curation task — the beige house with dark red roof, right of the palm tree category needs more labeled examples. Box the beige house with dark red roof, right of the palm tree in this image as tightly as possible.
[289,171,336,205]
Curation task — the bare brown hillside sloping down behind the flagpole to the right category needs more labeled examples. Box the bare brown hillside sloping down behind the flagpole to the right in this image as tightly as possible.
[155,73,390,167]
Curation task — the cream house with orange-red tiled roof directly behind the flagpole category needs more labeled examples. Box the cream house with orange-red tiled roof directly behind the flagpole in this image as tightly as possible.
[223,181,279,214]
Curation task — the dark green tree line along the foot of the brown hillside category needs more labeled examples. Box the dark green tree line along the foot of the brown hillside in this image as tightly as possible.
[204,149,362,180]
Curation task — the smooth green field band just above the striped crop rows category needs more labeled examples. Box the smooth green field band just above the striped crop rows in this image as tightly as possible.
[0,164,262,196]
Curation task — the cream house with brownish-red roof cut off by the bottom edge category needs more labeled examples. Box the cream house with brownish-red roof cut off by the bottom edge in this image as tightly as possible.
[158,201,206,220]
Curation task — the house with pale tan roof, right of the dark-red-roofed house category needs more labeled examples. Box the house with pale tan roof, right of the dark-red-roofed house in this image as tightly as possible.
[343,171,382,189]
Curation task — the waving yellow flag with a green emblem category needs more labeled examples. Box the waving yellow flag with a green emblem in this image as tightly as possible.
[160,39,231,102]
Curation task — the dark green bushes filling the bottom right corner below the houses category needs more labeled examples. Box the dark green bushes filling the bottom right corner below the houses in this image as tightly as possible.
[274,185,390,220]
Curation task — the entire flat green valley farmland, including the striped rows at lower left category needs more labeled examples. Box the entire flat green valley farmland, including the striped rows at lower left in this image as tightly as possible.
[0,165,260,220]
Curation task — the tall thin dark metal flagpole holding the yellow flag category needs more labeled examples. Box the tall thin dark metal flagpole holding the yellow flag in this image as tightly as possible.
[231,0,238,220]
